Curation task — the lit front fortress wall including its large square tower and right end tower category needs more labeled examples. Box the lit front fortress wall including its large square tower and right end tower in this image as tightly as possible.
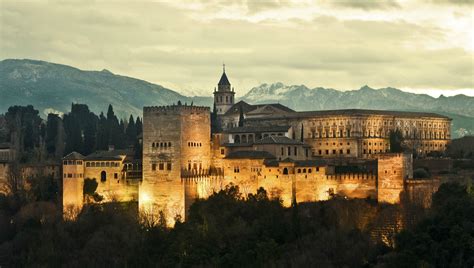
[139,102,430,225]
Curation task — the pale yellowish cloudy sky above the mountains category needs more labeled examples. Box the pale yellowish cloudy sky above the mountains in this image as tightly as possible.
[0,0,474,96]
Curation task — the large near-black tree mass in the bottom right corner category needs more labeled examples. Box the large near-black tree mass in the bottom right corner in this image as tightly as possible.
[381,183,474,267]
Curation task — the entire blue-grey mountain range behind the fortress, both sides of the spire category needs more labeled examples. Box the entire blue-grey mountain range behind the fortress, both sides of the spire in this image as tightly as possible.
[0,59,474,137]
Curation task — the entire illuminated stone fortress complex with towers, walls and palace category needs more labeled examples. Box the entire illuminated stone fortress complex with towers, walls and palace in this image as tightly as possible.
[63,66,451,225]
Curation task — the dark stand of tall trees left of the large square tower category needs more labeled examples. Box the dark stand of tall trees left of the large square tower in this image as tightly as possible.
[0,103,142,163]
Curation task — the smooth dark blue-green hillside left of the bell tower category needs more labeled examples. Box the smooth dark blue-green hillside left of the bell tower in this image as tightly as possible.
[0,60,212,118]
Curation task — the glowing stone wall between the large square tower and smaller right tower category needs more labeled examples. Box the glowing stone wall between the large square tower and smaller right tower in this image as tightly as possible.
[224,159,377,206]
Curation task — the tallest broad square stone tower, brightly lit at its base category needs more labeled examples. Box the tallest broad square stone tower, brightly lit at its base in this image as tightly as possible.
[139,104,211,225]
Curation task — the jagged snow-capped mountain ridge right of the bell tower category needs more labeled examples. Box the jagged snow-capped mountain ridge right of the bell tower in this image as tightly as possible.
[242,83,474,136]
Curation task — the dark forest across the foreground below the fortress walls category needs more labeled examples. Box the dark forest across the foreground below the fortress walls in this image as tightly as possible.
[0,183,474,267]
